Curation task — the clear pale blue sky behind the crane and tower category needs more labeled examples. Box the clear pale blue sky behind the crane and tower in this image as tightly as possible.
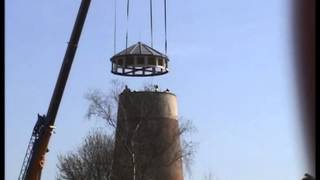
[5,0,307,180]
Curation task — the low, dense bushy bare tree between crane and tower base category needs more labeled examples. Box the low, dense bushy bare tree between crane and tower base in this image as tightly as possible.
[57,130,114,180]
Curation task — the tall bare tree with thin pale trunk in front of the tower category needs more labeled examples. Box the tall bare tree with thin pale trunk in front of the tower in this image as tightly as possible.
[86,80,195,180]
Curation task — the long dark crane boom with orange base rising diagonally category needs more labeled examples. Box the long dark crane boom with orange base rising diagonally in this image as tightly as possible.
[18,0,91,180]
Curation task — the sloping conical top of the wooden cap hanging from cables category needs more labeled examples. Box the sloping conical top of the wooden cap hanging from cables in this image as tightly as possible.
[111,42,167,59]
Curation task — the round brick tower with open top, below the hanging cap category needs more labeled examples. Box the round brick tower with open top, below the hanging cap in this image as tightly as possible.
[112,89,183,180]
